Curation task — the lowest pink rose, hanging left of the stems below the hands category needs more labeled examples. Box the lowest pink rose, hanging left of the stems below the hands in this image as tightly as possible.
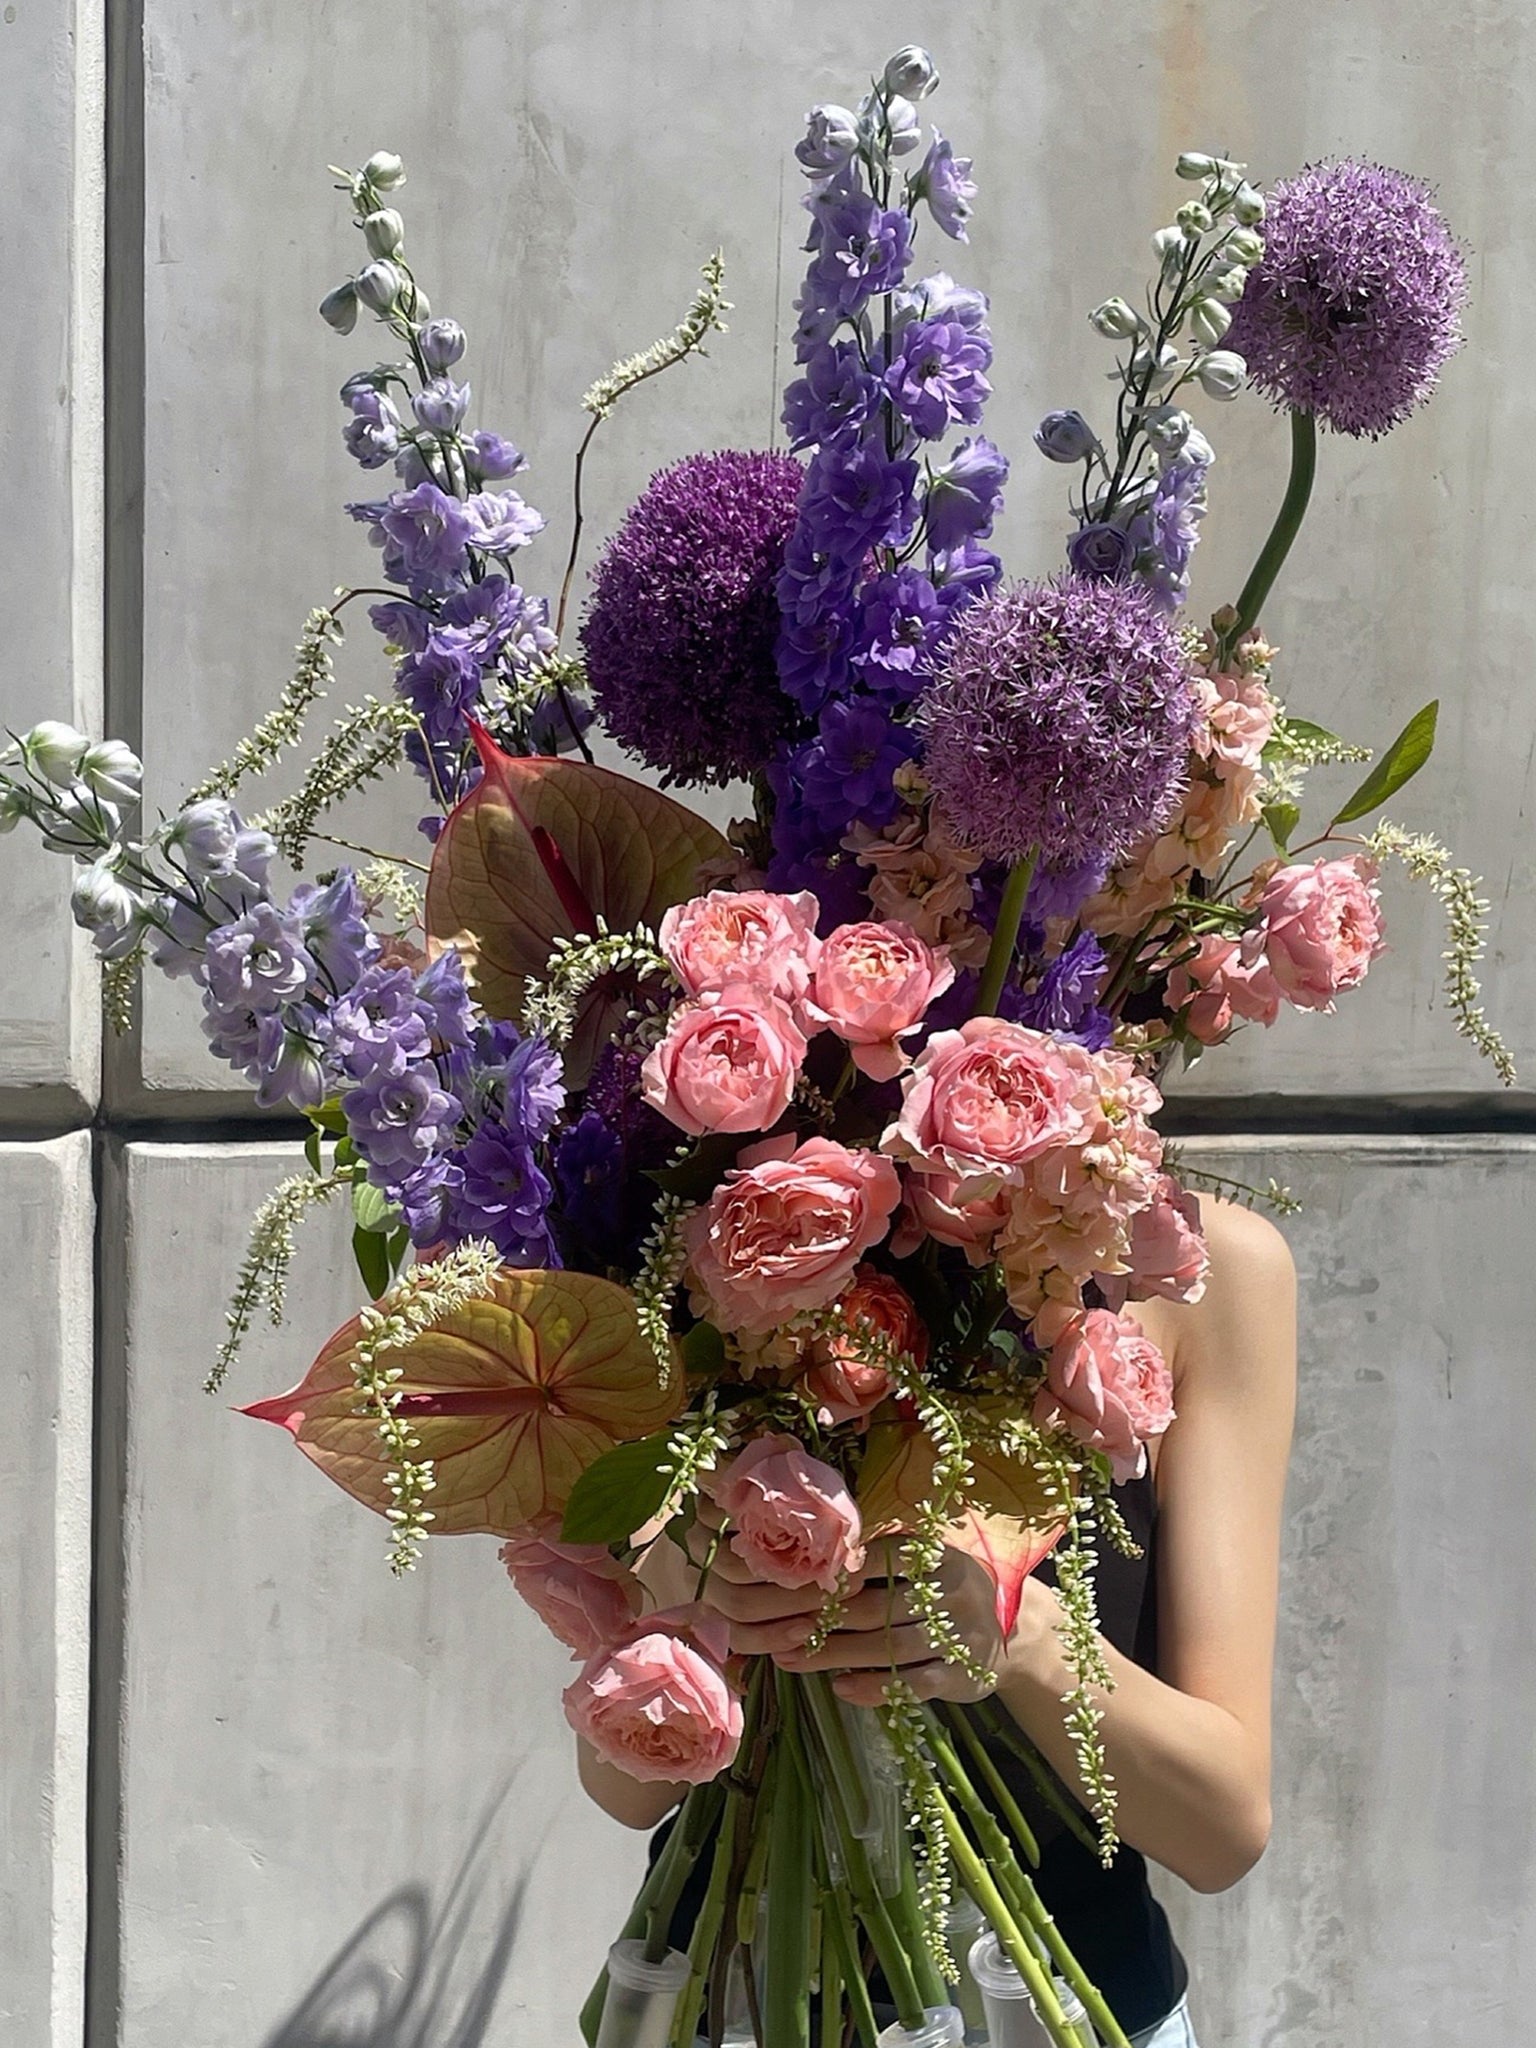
[563,1606,741,1786]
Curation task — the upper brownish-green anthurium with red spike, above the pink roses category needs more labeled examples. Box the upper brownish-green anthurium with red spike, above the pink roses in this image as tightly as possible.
[426,731,729,1081]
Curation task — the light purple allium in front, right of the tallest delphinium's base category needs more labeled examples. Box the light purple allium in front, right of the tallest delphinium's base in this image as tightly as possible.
[918,575,1194,870]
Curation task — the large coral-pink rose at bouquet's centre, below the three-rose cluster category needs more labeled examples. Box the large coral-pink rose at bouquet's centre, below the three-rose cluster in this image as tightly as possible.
[682,1139,901,1335]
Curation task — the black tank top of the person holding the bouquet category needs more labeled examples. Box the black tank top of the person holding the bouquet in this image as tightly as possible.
[651,1475,1190,2034]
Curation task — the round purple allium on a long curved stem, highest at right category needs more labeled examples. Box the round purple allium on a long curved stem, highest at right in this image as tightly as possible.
[1225,162,1466,438]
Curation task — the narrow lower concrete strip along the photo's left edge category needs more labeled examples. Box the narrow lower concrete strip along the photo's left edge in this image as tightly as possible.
[0,1133,92,2048]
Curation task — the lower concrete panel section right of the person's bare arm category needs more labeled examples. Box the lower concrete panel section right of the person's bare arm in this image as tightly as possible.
[1169,1139,1536,2048]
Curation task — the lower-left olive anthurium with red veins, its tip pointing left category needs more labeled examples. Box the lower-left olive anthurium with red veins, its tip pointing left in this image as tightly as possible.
[246,1261,684,1536]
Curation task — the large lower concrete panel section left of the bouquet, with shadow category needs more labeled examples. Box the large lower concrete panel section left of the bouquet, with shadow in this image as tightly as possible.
[94,1145,639,2048]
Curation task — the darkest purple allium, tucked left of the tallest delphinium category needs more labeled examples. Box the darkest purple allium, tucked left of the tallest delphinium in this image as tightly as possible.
[582,449,803,782]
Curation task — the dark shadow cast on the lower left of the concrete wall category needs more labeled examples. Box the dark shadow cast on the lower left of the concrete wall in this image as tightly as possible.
[262,1784,528,2048]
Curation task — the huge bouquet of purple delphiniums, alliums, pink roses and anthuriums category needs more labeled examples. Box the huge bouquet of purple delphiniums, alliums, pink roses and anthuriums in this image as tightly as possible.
[0,47,1511,2048]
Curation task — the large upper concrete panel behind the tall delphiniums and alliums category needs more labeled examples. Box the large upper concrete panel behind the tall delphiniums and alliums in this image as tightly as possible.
[129,0,1536,1094]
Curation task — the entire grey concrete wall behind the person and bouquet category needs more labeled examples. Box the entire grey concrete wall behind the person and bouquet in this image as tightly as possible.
[0,0,1536,2048]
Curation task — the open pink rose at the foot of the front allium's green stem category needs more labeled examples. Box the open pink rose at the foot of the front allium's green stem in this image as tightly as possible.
[881,1018,1085,1202]
